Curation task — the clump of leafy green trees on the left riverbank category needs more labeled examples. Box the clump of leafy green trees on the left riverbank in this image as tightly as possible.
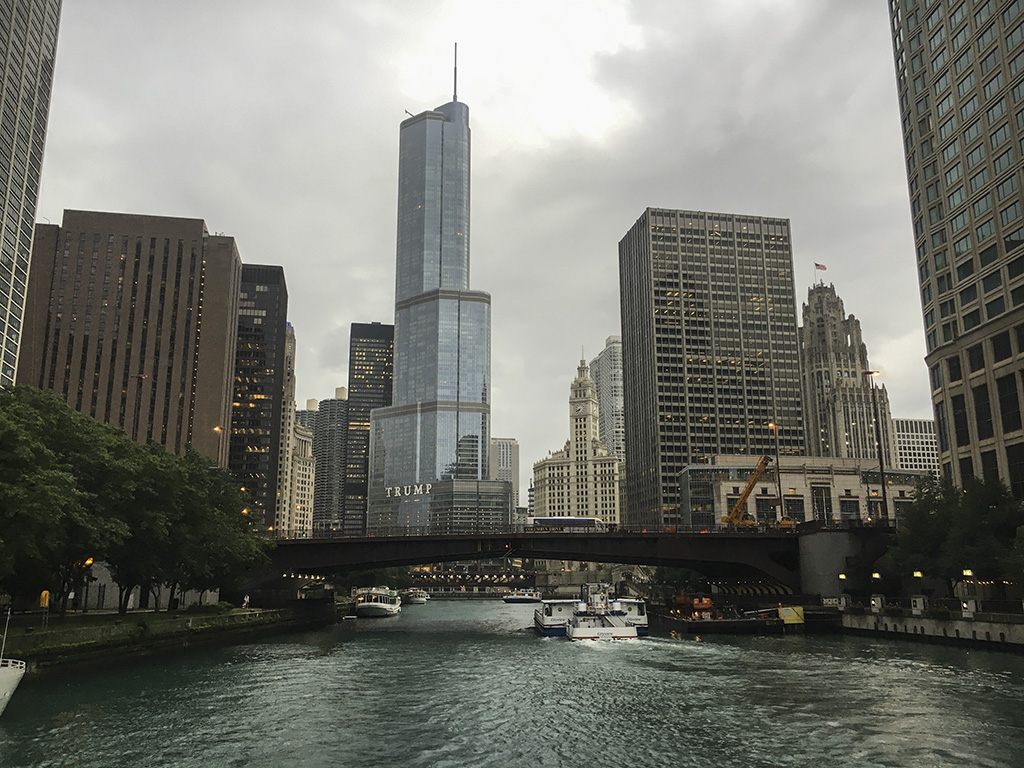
[0,387,272,612]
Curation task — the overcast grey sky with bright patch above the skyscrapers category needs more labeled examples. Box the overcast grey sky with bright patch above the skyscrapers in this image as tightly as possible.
[38,0,931,493]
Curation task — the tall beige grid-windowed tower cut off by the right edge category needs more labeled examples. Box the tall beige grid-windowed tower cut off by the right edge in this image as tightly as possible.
[889,0,1024,499]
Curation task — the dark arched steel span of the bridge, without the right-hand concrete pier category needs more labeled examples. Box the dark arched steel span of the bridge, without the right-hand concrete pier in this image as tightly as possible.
[256,532,800,591]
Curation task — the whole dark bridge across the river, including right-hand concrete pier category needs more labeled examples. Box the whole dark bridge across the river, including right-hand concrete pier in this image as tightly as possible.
[249,523,889,595]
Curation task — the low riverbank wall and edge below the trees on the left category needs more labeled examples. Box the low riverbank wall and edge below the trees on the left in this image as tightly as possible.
[4,599,338,674]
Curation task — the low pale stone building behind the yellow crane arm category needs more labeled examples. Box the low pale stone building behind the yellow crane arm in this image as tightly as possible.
[680,456,926,527]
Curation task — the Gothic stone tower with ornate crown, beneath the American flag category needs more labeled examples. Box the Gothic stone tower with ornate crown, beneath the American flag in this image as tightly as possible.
[800,283,895,467]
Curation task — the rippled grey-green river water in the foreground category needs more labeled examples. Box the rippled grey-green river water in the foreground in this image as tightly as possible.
[0,600,1024,768]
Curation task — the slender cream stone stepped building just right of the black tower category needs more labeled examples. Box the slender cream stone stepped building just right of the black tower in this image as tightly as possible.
[273,323,314,537]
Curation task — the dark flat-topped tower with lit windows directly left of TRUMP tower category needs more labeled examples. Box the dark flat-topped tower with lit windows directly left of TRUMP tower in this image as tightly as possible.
[341,323,394,536]
